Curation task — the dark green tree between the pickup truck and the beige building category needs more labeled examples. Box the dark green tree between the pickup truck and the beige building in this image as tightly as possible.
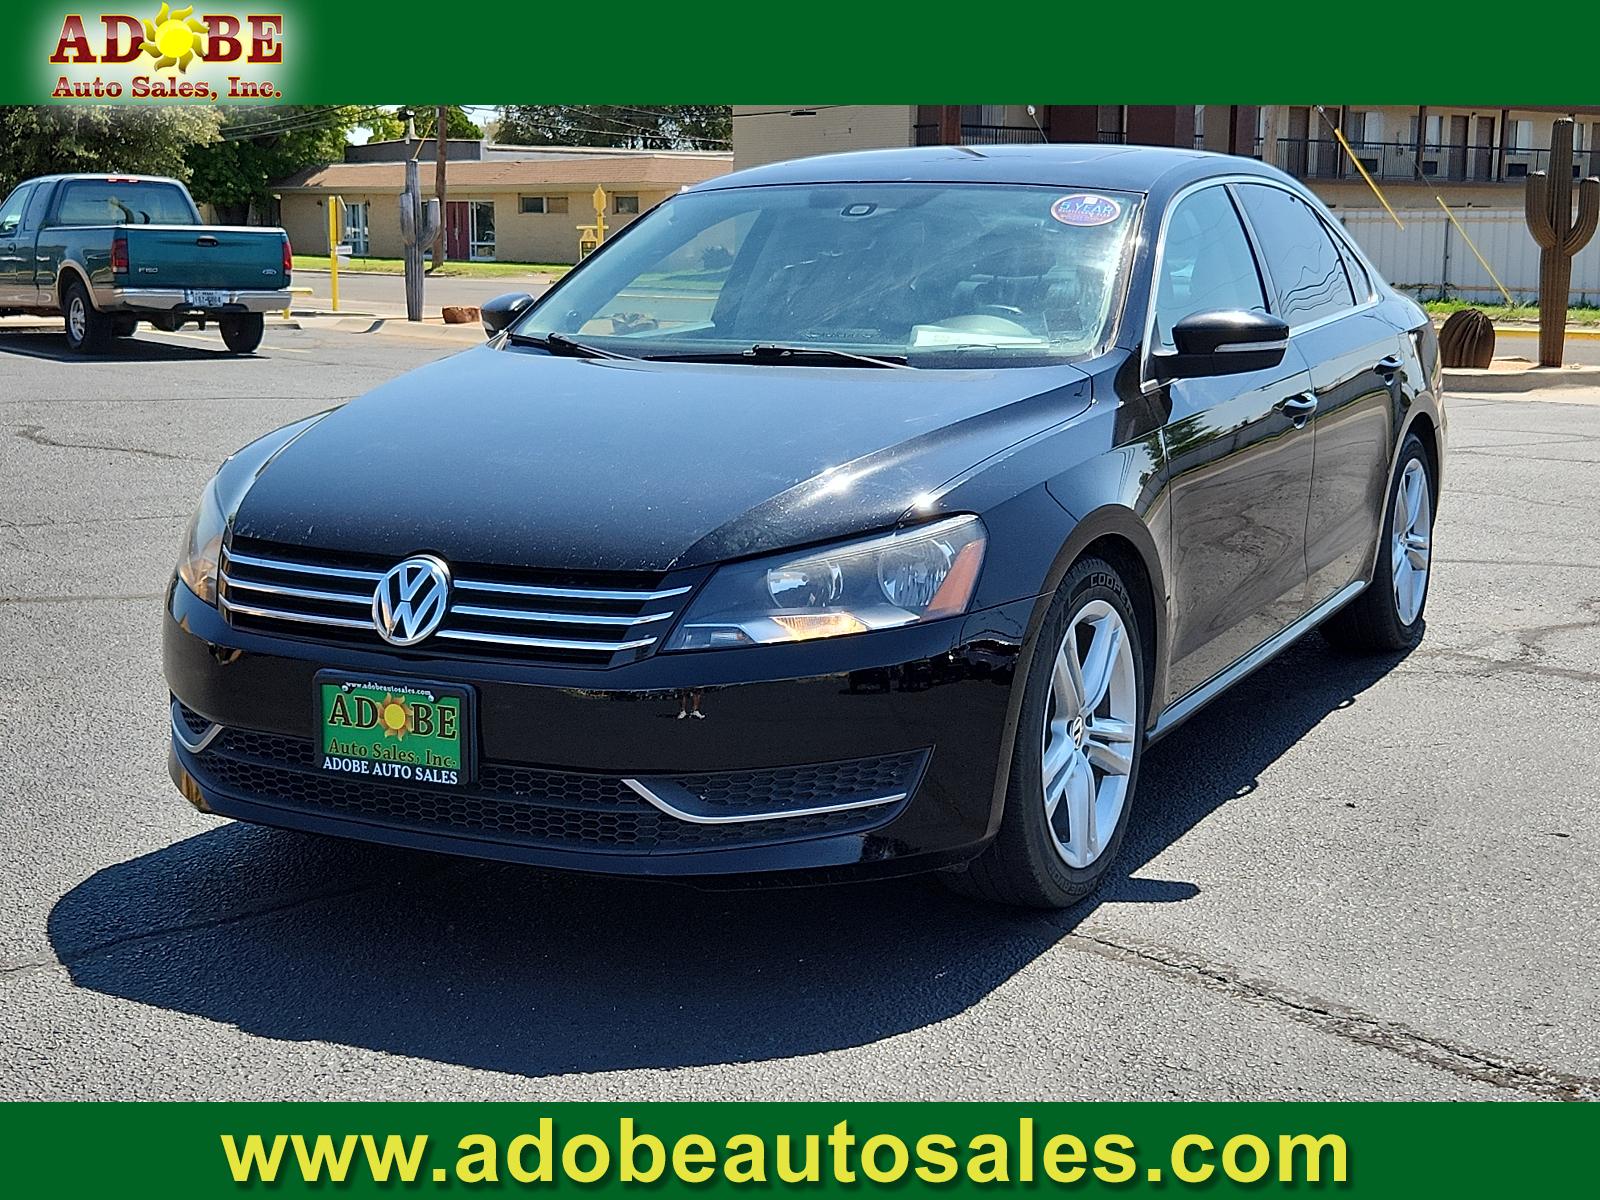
[189,104,364,222]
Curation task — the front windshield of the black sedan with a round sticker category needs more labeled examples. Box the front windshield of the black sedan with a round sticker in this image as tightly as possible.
[515,184,1138,366]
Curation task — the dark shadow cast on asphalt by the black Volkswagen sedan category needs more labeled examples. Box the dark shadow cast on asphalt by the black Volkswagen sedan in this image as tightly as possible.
[48,638,1398,1086]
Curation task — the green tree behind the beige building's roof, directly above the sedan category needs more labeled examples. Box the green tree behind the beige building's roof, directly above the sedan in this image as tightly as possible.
[494,104,733,150]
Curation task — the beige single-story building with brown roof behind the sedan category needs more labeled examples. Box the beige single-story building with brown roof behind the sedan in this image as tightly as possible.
[272,149,733,262]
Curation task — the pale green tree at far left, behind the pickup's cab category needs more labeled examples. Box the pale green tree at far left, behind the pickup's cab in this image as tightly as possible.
[0,104,222,194]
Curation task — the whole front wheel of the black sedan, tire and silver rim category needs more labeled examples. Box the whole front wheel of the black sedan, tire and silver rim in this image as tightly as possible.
[946,558,1147,909]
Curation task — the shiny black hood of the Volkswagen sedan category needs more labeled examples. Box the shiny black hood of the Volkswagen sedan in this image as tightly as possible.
[234,346,1090,571]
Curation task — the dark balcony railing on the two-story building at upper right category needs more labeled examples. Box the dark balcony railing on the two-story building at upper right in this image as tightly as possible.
[1277,138,1600,184]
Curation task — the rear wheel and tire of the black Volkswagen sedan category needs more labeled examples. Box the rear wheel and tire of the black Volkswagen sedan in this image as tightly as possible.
[1322,434,1434,654]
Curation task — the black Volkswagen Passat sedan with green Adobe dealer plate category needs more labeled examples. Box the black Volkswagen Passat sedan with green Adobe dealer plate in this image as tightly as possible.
[165,146,1445,906]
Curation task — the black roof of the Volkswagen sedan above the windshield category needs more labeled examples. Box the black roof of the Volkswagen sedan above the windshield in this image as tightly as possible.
[693,142,1288,194]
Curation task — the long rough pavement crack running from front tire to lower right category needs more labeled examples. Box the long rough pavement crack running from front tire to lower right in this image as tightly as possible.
[1064,928,1600,1101]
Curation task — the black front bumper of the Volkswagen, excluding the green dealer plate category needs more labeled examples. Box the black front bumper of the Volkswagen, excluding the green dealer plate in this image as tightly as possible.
[165,582,1035,875]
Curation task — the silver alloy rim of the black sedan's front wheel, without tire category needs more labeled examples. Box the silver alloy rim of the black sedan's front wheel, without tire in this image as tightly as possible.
[1042,600,1139,869]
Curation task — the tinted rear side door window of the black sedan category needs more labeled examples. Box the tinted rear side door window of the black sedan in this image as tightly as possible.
[1238,184,1355,330]
